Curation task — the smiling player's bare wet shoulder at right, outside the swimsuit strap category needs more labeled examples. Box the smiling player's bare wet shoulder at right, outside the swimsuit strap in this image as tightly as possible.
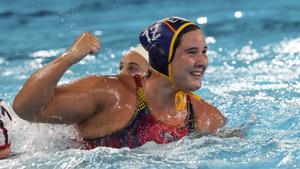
[191,93,226,133]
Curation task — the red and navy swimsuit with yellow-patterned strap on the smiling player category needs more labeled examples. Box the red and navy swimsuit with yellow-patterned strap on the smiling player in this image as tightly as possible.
[83,75,195,149]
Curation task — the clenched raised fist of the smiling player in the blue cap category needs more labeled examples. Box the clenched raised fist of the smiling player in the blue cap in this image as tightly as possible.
[67,32,101,65]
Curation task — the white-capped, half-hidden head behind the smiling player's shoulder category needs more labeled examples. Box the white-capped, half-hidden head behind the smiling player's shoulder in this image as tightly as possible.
[119,51,149,75]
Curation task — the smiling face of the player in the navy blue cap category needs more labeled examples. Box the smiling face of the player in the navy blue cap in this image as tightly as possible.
[171,30,208,91]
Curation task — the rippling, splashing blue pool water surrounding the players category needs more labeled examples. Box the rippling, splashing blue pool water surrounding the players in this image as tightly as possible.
[0,0,300,169]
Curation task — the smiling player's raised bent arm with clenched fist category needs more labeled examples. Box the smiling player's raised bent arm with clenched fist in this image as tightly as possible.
[13,33,100,123]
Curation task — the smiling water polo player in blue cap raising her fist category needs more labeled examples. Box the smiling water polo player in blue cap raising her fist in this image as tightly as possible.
[13,17,225,149]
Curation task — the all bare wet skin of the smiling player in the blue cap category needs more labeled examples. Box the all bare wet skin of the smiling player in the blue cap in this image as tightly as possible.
[13,31,225,138]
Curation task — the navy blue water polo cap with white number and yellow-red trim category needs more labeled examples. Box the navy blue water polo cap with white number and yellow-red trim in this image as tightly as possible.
[139,17,199,81]
